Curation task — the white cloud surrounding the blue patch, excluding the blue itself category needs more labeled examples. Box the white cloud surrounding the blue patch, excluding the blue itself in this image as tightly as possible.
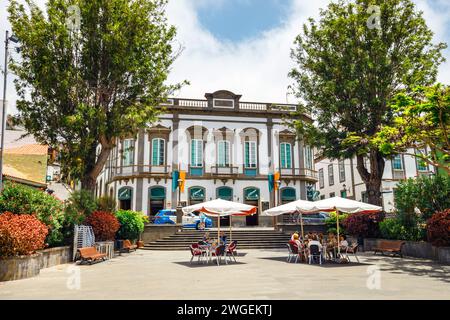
[0,0,450,112]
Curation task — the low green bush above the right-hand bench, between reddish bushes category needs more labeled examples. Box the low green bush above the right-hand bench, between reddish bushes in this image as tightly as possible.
[380,217,425,241]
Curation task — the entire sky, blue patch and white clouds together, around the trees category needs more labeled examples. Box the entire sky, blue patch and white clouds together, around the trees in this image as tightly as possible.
[0,0,450,109]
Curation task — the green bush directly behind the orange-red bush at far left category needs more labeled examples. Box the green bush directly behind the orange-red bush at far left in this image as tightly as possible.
[0,182,65,247]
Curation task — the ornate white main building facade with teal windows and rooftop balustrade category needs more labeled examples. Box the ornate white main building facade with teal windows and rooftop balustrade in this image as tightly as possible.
[96,90,317,226]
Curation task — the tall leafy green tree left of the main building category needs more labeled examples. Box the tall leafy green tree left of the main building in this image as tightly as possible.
[8,0,180,191]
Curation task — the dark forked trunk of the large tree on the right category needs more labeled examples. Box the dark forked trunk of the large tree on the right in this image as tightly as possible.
[356,149,385,207]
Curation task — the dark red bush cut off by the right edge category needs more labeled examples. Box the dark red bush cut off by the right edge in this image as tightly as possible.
[427,209,450,247]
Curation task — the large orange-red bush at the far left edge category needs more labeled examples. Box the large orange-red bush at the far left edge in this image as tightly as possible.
[0,212,48,258]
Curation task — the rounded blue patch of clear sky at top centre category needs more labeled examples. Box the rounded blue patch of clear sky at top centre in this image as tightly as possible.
[197,0,292,42]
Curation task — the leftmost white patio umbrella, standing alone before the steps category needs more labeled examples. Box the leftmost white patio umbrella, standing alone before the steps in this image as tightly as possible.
[182,199,257,244]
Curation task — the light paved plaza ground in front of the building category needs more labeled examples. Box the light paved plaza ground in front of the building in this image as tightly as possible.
[0,250,450,300]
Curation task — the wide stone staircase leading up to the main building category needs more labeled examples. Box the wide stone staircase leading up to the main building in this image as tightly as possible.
[143,229,290,250]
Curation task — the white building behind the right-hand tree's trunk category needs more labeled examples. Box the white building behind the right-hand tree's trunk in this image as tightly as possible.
[315,150,435,212]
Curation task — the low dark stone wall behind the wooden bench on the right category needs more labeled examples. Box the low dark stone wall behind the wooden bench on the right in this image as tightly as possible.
[364,238,450,264]
